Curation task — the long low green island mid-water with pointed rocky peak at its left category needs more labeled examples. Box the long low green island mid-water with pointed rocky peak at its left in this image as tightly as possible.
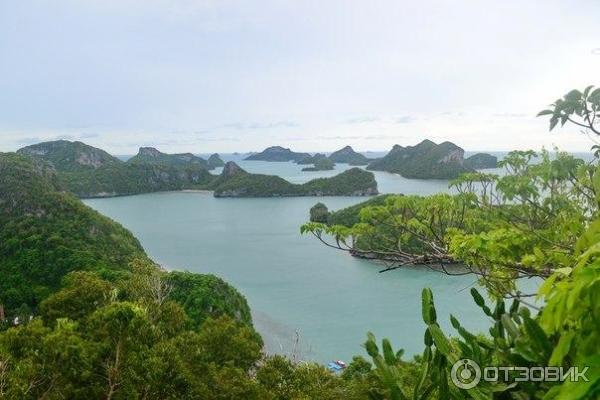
[209,161,378,197]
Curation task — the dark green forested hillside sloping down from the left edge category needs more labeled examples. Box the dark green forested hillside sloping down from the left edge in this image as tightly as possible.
[0,154,145,315]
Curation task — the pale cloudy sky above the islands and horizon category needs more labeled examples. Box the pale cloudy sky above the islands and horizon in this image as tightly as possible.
[0,0,600,154]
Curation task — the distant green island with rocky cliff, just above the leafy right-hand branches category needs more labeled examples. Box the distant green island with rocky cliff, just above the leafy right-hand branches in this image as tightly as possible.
[367,140,497,179]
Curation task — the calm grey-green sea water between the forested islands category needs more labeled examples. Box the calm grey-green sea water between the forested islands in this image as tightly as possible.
[85,156,536,362]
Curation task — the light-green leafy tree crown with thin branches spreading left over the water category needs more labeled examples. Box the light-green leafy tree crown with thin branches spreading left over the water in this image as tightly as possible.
[303,151,598,296]
